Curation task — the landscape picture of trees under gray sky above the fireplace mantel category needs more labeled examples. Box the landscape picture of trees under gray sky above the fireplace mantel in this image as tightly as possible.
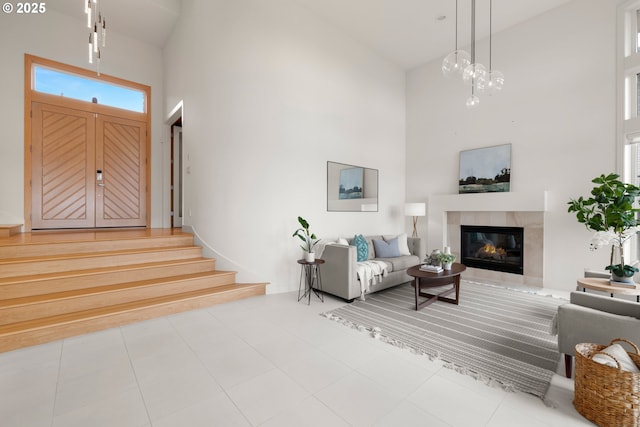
[458,144,511,194]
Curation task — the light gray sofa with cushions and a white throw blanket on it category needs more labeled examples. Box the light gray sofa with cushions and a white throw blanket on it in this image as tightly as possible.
[321,235,424,302]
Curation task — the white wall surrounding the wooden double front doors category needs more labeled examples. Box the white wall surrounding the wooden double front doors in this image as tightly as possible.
[0,10,169,227]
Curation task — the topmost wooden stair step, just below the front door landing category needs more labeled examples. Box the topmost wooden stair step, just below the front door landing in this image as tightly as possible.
[0,233,193,259]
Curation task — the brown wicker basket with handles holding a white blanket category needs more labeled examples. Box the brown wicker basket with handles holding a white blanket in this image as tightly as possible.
[573,338,640,427]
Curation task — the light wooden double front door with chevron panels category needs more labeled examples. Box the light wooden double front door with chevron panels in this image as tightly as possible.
[31,102,147,229]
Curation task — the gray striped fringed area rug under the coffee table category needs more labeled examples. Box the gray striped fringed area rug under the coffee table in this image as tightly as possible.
[323,280,566,399]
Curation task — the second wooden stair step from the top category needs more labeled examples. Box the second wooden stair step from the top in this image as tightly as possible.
[0,246,202,277]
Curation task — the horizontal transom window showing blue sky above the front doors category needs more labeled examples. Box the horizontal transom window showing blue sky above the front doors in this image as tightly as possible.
[32,65,146,113]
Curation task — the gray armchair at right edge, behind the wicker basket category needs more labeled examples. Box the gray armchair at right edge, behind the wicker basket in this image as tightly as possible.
[557,292,640,378]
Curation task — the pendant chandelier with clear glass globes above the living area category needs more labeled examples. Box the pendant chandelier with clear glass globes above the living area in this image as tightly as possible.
[442,0,504,108]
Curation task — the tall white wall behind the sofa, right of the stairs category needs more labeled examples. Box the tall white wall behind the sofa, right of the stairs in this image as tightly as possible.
[165,0,405,293]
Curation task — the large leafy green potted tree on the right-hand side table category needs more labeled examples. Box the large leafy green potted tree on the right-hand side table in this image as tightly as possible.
[568,173,640,283]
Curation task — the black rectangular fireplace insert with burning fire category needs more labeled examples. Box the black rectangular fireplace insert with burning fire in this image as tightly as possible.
[460,225,524,274]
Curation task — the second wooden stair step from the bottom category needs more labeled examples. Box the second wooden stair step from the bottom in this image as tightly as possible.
[0,271,236,325]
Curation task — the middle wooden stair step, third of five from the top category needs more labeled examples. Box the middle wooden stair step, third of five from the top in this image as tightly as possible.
[0,257,215,300]
